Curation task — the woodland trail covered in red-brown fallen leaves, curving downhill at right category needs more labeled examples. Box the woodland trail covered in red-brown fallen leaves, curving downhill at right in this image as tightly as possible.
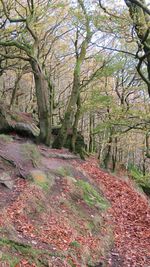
[78,161,150,267]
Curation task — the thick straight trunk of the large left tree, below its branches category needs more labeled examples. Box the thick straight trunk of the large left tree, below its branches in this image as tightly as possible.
[31,60,52,146]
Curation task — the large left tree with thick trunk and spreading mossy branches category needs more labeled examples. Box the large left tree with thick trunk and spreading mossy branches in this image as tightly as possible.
[0,0,68,145]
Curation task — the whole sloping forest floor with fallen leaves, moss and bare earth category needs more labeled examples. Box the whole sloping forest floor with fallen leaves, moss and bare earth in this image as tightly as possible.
[0,136,150,267]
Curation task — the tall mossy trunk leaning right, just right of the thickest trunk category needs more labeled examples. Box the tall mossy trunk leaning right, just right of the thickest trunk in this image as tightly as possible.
[53,0,92,148]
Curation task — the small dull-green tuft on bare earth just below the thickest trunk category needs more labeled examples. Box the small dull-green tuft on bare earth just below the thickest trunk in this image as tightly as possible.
[22,143,41,166]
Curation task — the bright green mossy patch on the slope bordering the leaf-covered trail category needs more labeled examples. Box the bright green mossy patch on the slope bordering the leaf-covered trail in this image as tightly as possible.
[77,180,109,210]
